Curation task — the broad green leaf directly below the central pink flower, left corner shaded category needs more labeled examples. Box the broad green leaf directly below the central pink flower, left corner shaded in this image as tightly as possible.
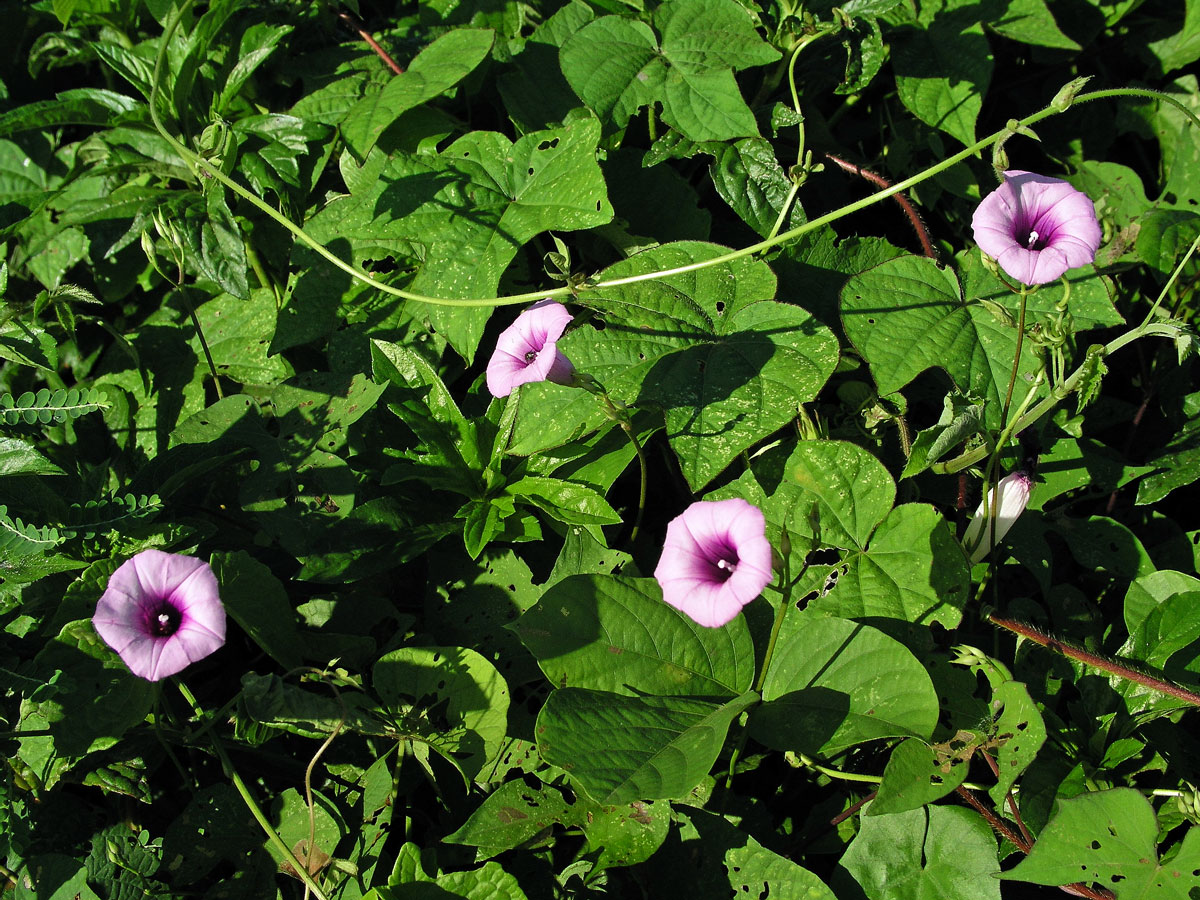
[511,575,755,697]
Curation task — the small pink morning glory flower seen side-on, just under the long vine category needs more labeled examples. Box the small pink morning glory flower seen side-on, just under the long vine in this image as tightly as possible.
[487,300,575,397]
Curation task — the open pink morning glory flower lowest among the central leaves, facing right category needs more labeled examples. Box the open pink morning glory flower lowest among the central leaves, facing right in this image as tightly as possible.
[654,498,772,628]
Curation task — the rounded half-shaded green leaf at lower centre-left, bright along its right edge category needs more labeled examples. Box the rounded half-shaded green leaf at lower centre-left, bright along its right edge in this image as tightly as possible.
[371,647,509,779]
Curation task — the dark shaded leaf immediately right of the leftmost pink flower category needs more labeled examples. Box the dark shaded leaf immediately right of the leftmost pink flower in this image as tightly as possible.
[211,550,302,670]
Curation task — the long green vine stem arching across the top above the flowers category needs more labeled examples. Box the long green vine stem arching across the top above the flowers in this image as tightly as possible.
[150,0,1200,307]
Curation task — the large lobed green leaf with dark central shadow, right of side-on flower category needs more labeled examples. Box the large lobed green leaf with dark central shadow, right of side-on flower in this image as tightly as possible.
[576,241,838,491]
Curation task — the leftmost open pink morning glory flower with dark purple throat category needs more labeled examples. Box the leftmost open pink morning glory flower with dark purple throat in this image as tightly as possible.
[91,550,226,682]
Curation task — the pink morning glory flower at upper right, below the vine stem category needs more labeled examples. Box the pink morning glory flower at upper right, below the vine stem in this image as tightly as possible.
[971,169,1100,284]
